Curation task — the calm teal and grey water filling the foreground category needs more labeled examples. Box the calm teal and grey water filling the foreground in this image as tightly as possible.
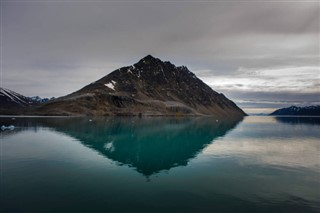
[0,117,320,213]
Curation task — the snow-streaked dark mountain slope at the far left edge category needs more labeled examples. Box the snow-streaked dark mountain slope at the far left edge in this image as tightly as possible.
[0,88,33,109]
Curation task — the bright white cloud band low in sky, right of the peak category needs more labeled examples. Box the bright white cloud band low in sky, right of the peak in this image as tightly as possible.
[200,66,320,93]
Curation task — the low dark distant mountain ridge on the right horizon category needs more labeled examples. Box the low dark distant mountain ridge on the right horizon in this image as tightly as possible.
[270,105,320,116]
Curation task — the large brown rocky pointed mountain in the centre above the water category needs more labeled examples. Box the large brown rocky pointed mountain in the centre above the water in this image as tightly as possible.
[36,55,246,116]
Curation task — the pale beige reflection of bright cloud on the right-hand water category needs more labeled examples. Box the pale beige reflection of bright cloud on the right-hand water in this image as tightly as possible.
[204,135,320,170]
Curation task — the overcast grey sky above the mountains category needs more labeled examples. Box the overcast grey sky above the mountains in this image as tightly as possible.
[0,0,320,113]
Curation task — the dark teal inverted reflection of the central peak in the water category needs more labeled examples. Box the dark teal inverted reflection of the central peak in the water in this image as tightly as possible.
[36,117,239,176]
